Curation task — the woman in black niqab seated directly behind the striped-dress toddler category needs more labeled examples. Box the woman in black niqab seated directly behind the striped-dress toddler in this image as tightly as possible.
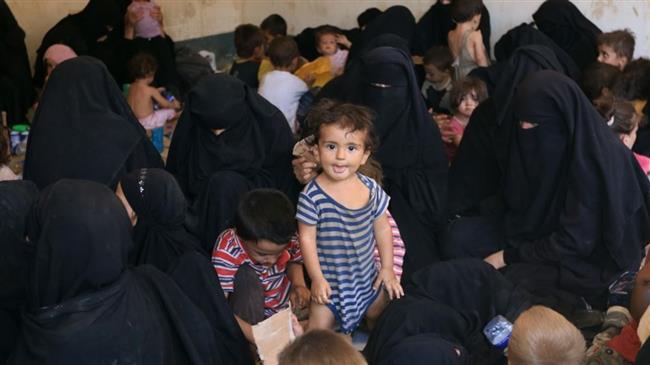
[323,45,448,280]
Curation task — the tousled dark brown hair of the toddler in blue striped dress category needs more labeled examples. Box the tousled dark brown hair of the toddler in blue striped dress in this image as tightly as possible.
[306,99,379,152]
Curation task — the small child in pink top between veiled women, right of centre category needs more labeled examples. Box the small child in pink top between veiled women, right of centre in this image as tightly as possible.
[441,77,487,162]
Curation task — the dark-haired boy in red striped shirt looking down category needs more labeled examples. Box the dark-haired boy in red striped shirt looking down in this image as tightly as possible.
[212,189,310,343]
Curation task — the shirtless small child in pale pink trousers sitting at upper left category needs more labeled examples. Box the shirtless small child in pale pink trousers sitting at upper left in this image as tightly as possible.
[127,53,181,129]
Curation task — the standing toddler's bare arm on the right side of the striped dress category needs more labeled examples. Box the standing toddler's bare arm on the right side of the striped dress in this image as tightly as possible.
[373,213,404,299]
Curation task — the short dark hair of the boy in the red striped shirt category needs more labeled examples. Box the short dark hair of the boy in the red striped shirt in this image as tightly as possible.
[235,189,296,245]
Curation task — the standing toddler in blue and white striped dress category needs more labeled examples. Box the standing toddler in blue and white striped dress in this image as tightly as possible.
[296,100,404,334]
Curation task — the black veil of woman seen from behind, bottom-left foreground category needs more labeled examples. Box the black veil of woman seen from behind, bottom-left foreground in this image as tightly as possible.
[8,180,220,364]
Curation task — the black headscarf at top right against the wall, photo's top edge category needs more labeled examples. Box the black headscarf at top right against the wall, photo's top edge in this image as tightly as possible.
[533,0,602,68]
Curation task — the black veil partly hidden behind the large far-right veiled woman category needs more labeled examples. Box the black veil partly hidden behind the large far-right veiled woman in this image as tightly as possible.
[449,45,565,216]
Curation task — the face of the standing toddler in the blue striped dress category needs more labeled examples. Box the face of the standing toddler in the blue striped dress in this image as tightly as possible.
[316,124,370,181]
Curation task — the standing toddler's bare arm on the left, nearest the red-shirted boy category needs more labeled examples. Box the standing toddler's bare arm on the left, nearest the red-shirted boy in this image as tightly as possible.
[298,222,332,304]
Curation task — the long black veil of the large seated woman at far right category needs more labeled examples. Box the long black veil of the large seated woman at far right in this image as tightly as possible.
[504,71,650,295]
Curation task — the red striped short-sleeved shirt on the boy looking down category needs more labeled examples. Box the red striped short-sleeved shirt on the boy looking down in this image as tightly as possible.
[212,228,302,317]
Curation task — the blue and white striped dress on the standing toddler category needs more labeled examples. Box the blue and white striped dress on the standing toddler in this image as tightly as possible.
[296,174,390,333]
